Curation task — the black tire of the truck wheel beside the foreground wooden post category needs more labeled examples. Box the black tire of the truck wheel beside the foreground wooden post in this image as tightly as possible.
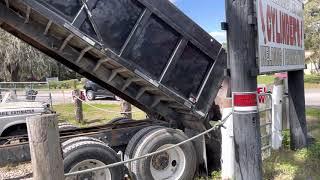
[63,141,124,180]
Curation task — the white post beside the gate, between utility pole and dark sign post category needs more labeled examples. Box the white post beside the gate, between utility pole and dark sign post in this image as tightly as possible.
[271,83,284,150]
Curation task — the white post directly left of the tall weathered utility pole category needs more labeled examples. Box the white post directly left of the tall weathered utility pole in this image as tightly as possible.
[221,99,235,180]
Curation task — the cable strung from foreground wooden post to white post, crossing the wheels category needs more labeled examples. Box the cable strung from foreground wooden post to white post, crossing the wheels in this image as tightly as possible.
[65,112,232,177]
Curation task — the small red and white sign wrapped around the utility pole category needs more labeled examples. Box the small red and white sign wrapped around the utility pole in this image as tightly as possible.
[233,92,258,113]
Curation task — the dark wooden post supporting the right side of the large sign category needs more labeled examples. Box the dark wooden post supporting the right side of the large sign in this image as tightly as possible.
[288,70,308,150]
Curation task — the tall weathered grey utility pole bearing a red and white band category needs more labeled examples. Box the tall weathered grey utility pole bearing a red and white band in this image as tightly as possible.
[226,0,262,180]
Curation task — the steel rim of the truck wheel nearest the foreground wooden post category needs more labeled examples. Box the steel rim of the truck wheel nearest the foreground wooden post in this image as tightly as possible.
[67,159,112,180]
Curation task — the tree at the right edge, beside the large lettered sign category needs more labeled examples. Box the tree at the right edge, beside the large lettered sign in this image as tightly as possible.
[305,0,320,73]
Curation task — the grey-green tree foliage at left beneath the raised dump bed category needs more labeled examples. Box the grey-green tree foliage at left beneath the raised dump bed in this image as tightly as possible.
[0,29,76,82]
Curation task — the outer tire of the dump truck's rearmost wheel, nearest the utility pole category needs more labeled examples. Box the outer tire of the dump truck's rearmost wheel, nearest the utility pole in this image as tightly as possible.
[131,128,197,180]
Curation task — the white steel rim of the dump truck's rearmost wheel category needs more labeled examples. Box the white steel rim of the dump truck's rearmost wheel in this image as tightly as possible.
[150,144,186,180]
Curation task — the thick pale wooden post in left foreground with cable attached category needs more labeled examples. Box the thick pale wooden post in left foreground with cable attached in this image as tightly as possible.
[27,115,64,180]
